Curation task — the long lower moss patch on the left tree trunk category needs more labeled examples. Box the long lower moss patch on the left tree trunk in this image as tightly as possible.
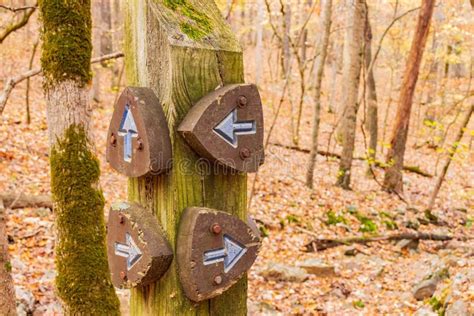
[51,125,119,315]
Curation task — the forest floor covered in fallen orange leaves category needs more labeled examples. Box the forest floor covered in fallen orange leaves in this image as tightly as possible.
[0,21,474,315]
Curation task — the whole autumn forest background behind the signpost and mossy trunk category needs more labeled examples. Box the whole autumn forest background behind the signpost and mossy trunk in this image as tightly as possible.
[0,0,474,315]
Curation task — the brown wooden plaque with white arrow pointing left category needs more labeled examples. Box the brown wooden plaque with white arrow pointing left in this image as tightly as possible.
[178,84,264,172]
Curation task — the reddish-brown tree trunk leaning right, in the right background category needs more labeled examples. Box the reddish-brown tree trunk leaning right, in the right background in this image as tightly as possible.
[383,0,435,193]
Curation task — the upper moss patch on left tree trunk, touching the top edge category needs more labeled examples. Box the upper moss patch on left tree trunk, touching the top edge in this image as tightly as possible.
[39,0,92,85]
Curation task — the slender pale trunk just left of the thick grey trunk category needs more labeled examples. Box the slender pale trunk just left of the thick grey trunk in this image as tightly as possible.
[306,0,332,188]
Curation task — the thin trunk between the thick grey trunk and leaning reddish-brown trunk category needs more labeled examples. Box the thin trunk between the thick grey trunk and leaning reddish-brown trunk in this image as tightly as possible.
[365,8,378,174]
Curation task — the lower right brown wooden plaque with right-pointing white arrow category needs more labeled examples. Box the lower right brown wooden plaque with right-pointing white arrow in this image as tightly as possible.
[177,207,260,302]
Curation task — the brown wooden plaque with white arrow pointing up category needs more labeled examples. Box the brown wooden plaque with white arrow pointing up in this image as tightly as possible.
[107,87,171,177]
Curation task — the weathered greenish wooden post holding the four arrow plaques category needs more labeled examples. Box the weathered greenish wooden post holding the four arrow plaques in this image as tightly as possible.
[124,0,247,315]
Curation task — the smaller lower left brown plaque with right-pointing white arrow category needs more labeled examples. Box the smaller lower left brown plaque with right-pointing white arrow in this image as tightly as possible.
[107,202,173,288]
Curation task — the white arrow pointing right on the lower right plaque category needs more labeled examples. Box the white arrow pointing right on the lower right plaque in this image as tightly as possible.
[203,235,247,273]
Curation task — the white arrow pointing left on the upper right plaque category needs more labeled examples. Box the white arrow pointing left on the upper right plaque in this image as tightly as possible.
[214,109,257,148]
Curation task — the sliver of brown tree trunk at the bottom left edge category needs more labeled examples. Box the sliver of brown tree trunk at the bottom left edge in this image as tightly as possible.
[0,199,16,316]
